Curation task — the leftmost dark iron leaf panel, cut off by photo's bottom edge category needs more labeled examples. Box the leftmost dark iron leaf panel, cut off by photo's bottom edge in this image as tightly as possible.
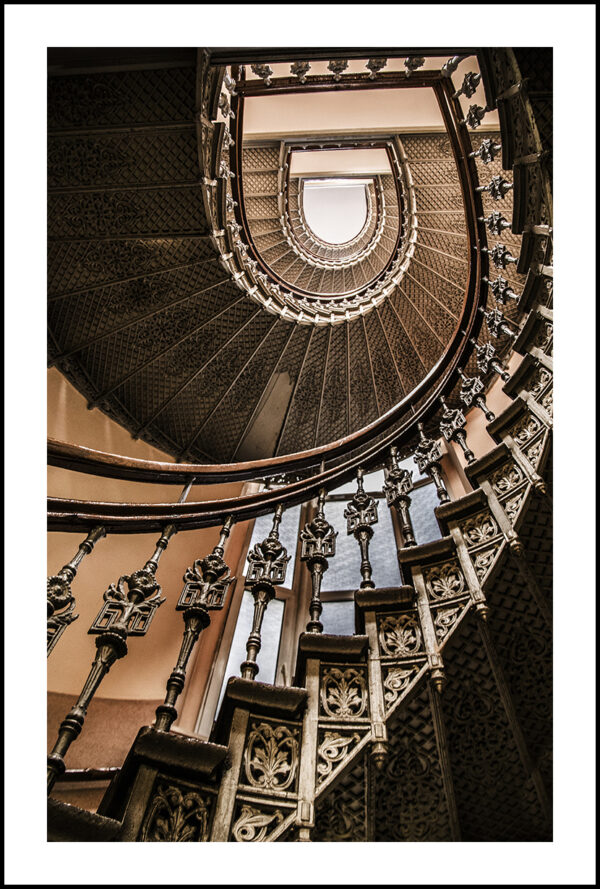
[140,784,208,843]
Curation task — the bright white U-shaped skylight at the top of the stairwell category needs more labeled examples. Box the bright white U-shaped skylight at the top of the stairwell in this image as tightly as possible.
[302,178,371,244]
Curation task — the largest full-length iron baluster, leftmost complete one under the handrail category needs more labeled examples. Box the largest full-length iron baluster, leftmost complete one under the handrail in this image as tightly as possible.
[48,525,176,793]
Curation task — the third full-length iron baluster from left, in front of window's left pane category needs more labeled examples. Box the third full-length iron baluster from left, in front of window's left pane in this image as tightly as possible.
[241,503,291,679]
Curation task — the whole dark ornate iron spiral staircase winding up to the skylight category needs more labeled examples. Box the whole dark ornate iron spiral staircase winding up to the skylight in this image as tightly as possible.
[48,49,552,842]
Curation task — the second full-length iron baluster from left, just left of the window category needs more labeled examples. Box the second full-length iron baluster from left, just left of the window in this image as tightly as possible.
[154,516,235,732]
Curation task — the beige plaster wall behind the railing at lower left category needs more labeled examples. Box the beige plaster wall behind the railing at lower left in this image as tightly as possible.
[48,370,247,716]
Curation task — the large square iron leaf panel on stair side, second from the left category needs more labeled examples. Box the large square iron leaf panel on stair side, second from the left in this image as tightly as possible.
[244,722,298,790]
